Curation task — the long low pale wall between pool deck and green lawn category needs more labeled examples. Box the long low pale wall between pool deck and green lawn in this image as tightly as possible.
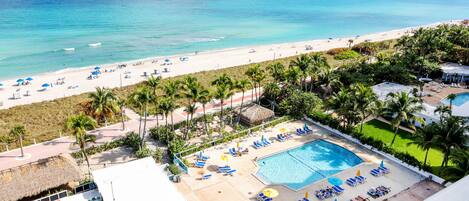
[304,117,445,184]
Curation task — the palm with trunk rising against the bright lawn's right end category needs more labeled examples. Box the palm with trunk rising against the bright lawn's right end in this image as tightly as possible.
[409,123,438,166]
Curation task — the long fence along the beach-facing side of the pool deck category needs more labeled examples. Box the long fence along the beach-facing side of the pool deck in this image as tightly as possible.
[173,116,293,173]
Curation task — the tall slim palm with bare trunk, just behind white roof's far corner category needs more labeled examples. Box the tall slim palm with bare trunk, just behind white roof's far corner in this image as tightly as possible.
[131,87,153,148]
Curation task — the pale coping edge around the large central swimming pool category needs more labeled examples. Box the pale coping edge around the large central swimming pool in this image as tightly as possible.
[251,138,367,192]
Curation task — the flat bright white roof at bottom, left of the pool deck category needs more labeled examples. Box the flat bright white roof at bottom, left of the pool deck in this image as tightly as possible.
[92,157,184,201]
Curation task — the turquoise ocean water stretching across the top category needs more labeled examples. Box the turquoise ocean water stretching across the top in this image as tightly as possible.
[0,0,469,79]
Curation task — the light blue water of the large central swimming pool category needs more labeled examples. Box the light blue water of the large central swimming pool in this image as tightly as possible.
[257,140,363,190]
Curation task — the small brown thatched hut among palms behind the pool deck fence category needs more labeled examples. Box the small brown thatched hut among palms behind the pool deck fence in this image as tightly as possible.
[240,104,275,125]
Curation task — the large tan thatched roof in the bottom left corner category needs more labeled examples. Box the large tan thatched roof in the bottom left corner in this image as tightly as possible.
[0,154,82,201]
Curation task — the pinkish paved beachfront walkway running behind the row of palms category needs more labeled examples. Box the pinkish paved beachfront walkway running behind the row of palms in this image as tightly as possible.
[0,91,260,171]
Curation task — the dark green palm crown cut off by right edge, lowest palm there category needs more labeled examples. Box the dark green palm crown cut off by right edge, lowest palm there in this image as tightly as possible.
[443,149,469,182]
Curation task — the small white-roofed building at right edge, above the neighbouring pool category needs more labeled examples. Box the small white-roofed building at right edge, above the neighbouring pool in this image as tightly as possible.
[441,63,469,83]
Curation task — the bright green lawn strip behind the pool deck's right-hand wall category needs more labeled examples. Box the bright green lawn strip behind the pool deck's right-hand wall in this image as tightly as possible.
[357,119,443,173]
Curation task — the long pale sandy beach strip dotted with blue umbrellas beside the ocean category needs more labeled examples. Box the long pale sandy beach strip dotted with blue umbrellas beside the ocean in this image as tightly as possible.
[0,21,459,109]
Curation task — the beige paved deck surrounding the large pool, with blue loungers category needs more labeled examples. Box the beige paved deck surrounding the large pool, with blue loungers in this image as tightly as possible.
[175,121,424,201]
